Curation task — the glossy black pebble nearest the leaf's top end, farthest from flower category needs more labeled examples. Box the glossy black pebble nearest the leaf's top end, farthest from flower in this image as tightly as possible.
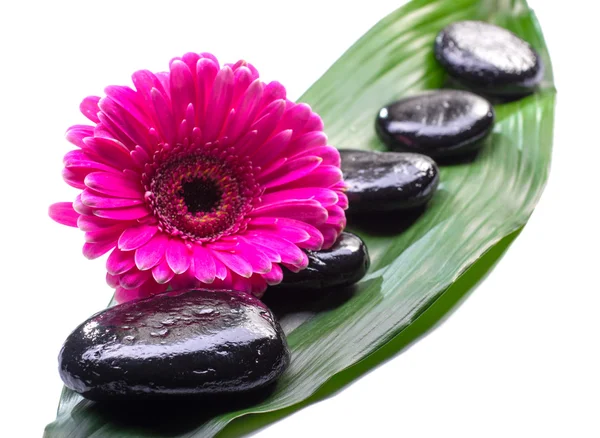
[435,21,544,97]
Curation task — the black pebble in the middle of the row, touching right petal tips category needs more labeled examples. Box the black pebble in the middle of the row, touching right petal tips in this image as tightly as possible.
[340,150,440,213]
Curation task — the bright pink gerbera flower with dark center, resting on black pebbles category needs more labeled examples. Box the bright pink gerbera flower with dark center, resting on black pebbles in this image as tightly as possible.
[50,53,348,302]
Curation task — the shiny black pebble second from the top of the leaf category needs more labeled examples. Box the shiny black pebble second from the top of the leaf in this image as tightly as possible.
[375,90,494,158]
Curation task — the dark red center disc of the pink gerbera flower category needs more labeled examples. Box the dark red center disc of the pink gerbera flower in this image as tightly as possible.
[146,151,260,241]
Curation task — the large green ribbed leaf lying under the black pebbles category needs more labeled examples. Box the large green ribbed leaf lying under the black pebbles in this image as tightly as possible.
[45,0,555,437]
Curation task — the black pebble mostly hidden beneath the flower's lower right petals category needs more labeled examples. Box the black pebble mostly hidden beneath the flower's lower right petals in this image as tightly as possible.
[277,232,371,289]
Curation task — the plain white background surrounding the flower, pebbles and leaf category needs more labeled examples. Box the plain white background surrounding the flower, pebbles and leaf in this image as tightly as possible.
[0,0,600,438]
